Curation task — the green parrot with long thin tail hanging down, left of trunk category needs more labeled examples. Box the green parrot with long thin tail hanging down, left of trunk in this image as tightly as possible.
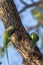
[2,26,15,65]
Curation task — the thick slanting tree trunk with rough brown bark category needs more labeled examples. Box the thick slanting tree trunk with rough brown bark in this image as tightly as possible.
[0,0,43,65]
